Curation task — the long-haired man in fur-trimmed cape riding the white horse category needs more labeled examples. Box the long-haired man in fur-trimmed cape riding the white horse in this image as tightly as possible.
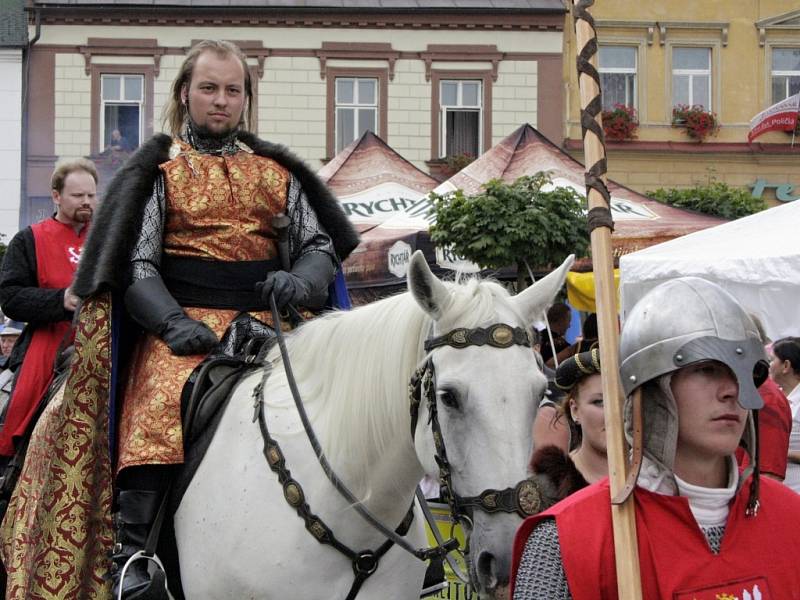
[0,41,358,599]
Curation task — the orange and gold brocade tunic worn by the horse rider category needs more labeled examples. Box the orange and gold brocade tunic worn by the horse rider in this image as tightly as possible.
[117,140,291,472]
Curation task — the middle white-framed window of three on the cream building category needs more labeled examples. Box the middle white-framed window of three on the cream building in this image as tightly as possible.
[335,77,381,153]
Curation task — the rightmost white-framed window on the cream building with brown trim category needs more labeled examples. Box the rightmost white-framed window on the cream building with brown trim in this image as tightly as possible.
[439,79,483,157]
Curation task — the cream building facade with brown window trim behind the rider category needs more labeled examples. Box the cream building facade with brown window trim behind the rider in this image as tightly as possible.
[22,0,566,227]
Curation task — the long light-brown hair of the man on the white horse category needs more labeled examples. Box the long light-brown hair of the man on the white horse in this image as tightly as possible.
[163,40,255,136]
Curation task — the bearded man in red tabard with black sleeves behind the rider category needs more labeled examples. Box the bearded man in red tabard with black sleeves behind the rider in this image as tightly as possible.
[0,159,97,457]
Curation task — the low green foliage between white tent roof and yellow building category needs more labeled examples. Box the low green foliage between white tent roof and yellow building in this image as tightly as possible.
[647,179,767,219]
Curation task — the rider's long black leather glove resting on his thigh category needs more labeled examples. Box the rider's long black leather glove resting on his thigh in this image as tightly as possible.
[125,276,219,356]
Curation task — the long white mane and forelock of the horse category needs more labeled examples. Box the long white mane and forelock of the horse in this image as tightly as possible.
[271,278,523,497]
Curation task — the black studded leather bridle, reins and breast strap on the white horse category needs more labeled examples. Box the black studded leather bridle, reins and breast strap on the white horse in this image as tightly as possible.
[260,296,541,600]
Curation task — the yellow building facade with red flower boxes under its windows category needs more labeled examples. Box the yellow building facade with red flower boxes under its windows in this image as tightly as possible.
[564,0,800,204]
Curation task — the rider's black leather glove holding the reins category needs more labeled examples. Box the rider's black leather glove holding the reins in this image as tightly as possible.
[256,252,336,310]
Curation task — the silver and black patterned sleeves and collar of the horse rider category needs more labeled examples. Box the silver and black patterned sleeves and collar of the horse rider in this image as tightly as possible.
[131,124,336,281]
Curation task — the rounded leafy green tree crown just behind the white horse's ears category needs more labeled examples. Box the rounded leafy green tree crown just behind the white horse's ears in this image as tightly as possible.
[431,172,589,284]
